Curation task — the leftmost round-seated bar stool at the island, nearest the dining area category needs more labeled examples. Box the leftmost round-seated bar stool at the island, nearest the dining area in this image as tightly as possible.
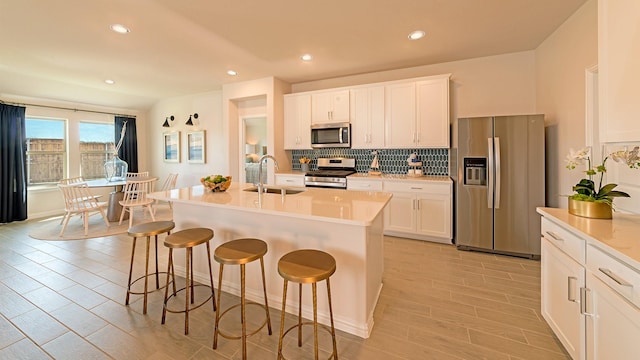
[124,221,176,314]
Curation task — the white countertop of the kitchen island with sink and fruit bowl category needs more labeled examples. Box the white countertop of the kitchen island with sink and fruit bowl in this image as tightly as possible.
[149,183,392,226]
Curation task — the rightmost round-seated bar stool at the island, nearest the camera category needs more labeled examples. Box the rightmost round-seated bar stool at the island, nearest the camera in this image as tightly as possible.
[277,249,338,360]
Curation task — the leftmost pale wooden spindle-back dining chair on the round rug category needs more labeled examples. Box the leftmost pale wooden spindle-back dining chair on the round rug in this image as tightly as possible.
[58,183,110,236]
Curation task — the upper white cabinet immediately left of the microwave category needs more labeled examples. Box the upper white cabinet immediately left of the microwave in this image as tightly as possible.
[284,94,311,150]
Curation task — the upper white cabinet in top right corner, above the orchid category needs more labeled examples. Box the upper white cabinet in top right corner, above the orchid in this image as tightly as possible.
[598,0,640,142]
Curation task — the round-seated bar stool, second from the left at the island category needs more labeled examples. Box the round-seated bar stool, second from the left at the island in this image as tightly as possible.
[162,228,216,335]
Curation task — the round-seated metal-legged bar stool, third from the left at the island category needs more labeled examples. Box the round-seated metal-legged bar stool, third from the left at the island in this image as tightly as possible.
[213,239,271,359]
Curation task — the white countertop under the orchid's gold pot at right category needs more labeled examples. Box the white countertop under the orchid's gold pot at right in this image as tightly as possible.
[538,208,640,269]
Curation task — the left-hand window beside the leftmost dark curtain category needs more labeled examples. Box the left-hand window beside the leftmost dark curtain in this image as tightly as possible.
[25,118,67,186]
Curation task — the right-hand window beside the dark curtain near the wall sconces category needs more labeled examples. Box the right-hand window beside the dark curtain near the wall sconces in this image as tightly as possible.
[80,122,115,180]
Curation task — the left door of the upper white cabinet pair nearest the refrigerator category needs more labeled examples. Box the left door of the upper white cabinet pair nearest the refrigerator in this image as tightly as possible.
[384,82,416,149]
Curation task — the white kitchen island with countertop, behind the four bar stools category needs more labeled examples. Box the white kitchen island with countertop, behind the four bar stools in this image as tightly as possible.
[149,183,391,338]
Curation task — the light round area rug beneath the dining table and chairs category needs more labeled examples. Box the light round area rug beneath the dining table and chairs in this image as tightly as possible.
[29,205,173,240]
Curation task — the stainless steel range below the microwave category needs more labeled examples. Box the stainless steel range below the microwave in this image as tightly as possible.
[304,158,356,189]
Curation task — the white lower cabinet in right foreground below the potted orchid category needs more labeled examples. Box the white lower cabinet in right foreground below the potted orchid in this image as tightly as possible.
[539,208,640,360]
